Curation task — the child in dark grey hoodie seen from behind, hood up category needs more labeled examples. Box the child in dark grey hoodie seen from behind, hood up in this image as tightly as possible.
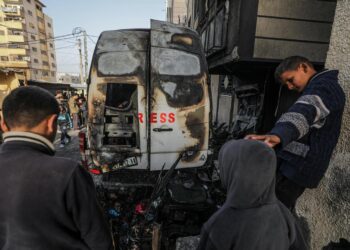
[198,140,307,250]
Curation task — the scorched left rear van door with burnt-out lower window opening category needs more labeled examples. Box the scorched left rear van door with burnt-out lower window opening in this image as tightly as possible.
[87,30,149,172]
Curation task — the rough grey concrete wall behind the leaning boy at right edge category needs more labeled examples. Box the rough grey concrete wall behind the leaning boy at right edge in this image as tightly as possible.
[297,0,350,250]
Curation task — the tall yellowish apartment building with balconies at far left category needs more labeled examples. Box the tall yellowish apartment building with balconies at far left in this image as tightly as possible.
[0,0,56,87]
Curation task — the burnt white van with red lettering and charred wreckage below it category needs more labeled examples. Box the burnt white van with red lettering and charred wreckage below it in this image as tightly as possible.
[80,20,221,249]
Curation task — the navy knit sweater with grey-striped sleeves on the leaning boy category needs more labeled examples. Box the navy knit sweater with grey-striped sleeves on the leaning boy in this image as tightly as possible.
[269,70,345,188]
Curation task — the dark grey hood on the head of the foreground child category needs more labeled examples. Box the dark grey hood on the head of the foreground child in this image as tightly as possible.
[219,139,276,208]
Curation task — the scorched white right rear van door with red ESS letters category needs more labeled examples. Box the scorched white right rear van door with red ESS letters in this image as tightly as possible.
[148,20,210,170]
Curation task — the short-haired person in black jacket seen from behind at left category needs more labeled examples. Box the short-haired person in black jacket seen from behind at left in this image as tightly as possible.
[0,86,113,250]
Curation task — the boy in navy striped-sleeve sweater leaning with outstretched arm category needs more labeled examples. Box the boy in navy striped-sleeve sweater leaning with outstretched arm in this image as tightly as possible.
[246,56,345,209]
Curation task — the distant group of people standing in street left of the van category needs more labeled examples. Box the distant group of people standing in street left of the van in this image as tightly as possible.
[55,90,87,147]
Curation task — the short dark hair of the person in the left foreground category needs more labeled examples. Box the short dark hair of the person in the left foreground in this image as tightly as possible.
[2,86,60,128]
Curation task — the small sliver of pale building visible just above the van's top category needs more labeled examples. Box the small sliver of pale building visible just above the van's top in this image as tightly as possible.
[167,0,188,26]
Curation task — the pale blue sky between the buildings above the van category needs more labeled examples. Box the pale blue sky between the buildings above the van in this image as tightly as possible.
[41,0,166,73]
